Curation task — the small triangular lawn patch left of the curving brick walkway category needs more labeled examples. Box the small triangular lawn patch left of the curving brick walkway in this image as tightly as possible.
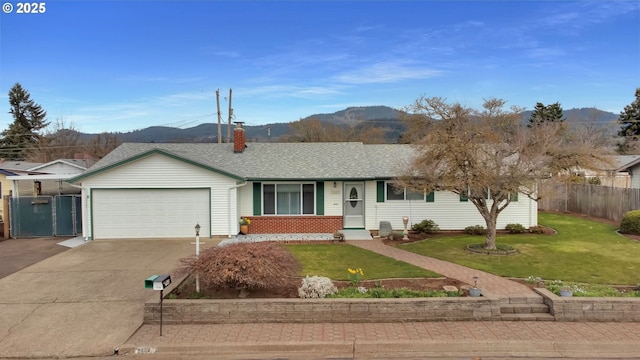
[285,244,442,280]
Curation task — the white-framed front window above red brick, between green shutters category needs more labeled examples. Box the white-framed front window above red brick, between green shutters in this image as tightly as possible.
[262,183,316,215]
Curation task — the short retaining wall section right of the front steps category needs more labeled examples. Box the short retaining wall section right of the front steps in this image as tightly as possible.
[535,289,640,322]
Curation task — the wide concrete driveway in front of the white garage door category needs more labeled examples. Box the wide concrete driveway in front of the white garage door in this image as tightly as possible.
[0,239,215,358]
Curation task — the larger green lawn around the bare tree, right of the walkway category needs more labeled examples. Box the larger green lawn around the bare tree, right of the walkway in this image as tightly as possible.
[401,212,640,285]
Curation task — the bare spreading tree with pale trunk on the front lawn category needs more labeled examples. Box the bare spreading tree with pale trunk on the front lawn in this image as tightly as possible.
[398,97,608,249]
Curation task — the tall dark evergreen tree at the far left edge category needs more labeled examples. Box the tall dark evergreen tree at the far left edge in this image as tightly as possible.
[0,83,49,160]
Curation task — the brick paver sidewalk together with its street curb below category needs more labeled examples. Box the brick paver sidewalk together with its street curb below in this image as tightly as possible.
[120,321,640,359]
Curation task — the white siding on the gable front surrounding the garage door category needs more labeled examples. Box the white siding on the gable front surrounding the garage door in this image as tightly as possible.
[82,154,237,237]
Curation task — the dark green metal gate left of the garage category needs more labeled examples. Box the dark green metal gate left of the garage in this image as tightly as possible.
[9,195,82,238]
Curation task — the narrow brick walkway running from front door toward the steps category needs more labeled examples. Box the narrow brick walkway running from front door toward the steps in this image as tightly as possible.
[347,239,536,297]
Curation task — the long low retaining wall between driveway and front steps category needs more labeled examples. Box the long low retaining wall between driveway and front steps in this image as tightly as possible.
[144,297,500,324]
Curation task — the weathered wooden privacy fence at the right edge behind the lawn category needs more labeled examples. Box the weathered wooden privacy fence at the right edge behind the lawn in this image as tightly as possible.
[538,183,640,221]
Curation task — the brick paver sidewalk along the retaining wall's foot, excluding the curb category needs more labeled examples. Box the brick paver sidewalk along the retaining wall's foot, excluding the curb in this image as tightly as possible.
[127,321,640,344]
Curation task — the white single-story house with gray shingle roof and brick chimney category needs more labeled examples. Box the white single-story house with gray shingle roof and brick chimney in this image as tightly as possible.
[69,128,537,239]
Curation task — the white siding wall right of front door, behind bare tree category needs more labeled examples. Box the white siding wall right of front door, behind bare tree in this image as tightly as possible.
[365,181,538,230]
